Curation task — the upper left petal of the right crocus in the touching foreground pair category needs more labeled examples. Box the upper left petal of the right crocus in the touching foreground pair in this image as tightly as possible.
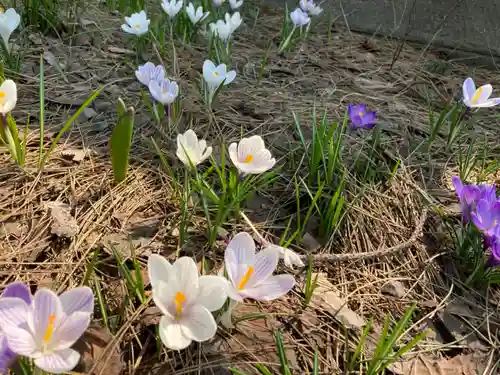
[224,232,255,284]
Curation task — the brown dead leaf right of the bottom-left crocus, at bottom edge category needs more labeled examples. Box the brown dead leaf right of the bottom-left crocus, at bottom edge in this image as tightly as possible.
[73,324,124,375]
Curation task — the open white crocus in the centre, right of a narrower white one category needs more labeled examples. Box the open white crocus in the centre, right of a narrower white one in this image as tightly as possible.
[229,135,276,174]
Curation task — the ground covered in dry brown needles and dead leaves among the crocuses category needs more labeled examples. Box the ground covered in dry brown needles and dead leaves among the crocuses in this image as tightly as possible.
[0,3,500,375]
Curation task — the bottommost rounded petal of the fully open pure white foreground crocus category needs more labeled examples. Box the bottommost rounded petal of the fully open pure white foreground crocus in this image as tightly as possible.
[181,305,217,342]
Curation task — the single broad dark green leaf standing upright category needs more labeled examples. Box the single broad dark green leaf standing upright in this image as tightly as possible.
[110,99,135,182]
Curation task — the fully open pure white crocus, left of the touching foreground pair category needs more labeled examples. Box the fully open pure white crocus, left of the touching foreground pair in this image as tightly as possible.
[148,254,227,350]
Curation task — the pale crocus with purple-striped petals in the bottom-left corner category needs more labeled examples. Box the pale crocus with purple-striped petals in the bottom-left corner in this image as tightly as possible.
[0,287,94,374]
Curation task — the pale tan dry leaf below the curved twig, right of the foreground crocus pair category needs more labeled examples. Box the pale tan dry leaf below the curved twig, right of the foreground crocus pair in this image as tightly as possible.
[312,273,366,328]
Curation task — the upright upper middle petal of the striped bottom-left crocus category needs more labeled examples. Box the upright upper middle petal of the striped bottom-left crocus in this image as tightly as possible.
[33,288,65,342]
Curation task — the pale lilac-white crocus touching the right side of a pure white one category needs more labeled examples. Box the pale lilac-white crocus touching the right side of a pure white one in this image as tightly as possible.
[222,232,295,326]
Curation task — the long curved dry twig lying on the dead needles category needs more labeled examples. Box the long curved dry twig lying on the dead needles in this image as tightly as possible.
[240,208,427,262]
